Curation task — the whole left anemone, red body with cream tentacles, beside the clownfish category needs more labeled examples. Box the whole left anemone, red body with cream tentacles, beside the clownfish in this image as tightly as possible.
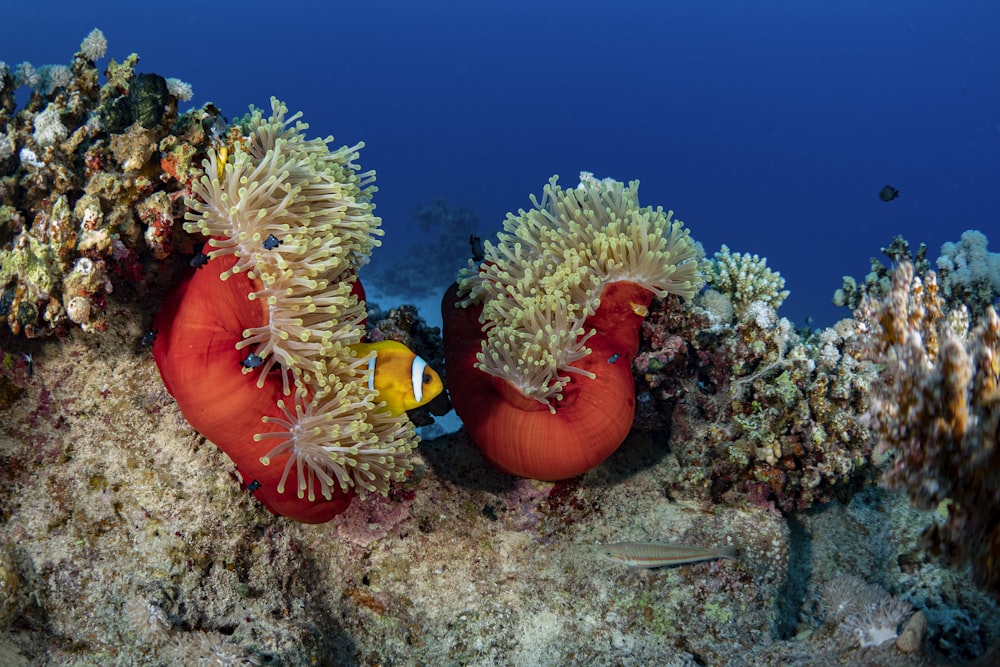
[153,99,429,523]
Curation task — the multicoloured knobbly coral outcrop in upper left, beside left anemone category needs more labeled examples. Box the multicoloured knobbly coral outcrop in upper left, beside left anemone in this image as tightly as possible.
[0,30,218,338]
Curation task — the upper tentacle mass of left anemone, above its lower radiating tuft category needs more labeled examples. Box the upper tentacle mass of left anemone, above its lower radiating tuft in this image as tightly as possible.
[184,100,382,394]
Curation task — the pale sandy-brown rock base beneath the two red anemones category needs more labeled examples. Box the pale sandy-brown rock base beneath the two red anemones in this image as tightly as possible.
[0,306,1000,667]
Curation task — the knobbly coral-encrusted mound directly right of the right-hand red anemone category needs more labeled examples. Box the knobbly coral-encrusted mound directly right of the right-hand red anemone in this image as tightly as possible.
[634,263,874,512]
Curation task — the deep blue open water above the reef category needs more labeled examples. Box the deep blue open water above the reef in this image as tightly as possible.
[0,0,1000,324]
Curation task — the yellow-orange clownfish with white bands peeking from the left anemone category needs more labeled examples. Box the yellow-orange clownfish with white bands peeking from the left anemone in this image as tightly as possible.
[351,340,444,415]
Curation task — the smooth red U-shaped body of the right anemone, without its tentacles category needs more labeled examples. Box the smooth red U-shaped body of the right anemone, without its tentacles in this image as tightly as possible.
[442,282,653,480]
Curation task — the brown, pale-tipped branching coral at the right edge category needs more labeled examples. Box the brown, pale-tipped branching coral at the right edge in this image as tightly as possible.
[857,262,1000,592]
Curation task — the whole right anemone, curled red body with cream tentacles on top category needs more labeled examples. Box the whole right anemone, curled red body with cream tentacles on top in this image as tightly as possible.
[442,173,701,480]
